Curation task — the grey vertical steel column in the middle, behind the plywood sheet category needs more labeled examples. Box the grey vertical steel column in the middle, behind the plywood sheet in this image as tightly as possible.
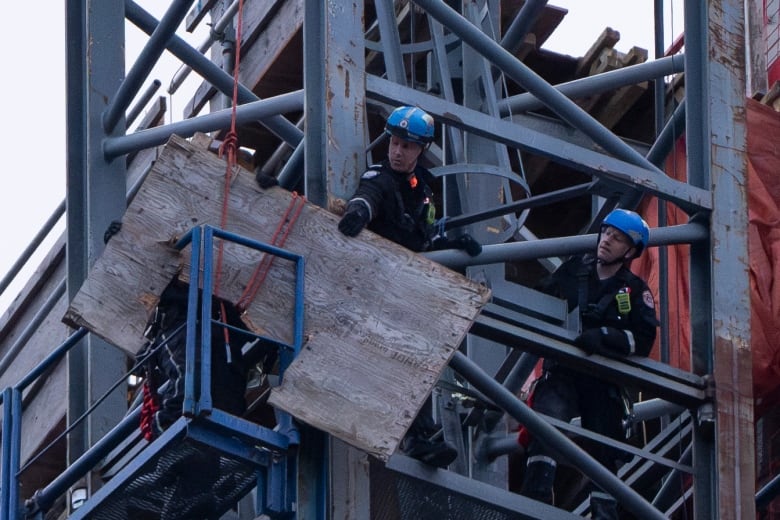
[302,0,370,518]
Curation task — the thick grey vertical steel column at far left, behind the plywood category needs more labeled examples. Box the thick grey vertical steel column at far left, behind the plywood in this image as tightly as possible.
[66,0,127,506]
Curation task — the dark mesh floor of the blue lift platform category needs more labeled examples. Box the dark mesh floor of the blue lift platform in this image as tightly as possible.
[87,438,257,520]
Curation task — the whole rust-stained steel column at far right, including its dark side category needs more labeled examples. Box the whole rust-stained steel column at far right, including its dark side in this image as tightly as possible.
[685,0,755,518]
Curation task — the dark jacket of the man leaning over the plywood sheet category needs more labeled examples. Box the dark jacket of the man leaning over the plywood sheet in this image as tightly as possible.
[351,160,435,253]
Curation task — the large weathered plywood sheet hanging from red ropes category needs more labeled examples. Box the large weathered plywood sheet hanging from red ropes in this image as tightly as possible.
[63,136,490,460]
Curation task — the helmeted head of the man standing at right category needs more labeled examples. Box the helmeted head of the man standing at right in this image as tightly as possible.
[596,209,650,264]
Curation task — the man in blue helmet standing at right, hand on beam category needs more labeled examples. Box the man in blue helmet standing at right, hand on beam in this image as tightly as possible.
[520,209,658,519]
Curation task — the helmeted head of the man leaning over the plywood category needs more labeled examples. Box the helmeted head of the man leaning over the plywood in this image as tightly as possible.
[385,106,434,173]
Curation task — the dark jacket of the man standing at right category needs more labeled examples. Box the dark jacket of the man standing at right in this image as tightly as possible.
[539,255,658,356]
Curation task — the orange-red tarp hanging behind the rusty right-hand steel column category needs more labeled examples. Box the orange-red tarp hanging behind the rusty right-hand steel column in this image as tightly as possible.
[632,99,780,418]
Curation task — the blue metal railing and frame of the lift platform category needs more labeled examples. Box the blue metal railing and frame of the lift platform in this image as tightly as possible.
[5,225,304,520]
